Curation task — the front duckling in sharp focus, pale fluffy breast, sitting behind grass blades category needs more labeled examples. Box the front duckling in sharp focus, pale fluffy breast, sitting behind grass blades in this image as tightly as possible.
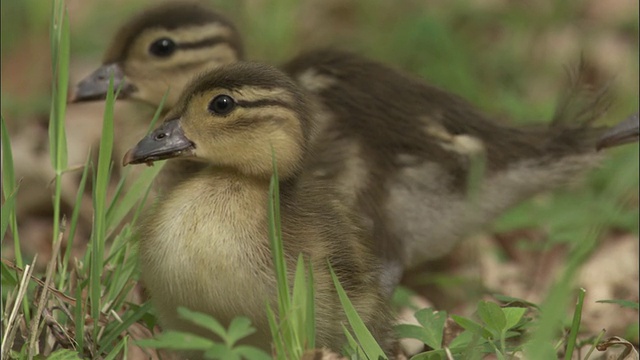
[123,63,391,351]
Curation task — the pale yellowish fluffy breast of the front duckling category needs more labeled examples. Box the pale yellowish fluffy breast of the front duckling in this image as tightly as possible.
[140,171,274,334]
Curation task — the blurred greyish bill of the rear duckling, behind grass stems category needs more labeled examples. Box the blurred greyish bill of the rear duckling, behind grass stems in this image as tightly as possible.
[72,63,135,102]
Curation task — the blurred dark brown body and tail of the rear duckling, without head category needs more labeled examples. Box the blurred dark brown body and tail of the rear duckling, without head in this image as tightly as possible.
[284,50,609,285]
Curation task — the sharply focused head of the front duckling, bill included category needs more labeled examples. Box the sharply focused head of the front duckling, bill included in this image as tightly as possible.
[123,63,312,179]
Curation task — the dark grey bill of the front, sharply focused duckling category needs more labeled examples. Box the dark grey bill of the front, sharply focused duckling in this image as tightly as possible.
[122,119,195,166]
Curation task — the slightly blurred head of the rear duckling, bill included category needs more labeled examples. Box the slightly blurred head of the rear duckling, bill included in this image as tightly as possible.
[74,1,243,108]
